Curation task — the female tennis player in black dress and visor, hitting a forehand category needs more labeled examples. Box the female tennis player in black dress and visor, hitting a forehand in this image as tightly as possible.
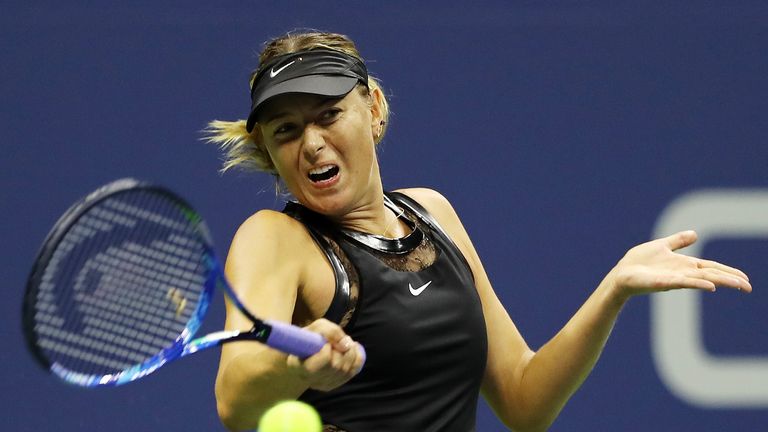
[209,32,752,432]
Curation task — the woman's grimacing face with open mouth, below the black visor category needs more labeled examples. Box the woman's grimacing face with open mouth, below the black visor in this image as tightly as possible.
[259,89,382,218]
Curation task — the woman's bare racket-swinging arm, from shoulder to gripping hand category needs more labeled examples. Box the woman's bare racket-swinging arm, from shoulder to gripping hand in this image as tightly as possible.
[216,210,362,430]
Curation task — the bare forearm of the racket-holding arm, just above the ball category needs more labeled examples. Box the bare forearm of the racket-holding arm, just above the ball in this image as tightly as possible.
[216,349,307,430]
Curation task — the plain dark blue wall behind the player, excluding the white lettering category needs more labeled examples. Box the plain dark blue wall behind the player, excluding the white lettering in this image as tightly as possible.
[0,1,768,431]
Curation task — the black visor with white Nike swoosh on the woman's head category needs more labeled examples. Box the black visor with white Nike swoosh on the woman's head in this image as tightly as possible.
[246,49,368,132]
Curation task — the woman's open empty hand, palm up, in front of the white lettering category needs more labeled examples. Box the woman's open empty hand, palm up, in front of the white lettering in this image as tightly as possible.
[606,231,752,300]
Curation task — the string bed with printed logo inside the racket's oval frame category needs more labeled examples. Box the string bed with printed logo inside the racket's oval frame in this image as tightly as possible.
[35,190,207,375]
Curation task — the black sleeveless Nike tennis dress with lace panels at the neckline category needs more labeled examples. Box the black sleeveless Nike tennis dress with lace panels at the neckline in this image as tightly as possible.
[284,193,487,432]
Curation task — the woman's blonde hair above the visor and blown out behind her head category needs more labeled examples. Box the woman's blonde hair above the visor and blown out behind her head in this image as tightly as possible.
[203,31,389,176]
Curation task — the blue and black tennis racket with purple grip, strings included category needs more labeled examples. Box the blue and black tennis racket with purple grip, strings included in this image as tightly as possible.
[22,179,362,387]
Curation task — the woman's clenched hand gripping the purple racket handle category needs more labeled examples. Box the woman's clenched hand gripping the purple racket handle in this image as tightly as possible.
[287,318,364,391]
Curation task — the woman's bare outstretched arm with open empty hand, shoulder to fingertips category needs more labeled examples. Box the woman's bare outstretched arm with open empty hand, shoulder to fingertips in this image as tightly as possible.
[404,189,752,431]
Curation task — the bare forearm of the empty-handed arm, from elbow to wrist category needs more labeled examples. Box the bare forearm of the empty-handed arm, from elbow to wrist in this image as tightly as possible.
[519,278,626,430]
